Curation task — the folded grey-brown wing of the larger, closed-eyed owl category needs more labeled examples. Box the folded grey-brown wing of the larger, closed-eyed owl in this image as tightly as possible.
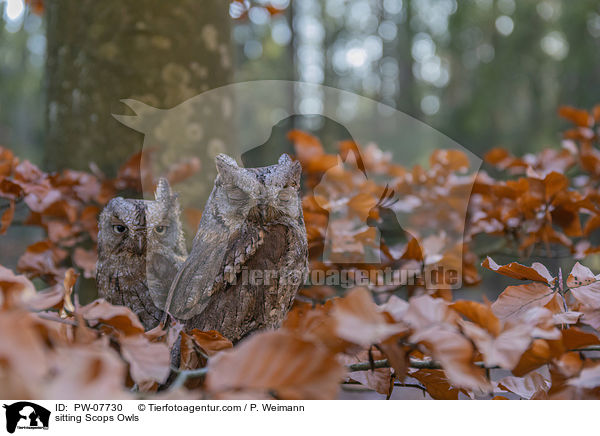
[166,225,264,319]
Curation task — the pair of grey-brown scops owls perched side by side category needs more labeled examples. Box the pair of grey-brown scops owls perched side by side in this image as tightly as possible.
[97,154,308,342]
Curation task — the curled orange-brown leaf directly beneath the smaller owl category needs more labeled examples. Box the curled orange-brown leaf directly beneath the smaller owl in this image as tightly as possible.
[79,299,144,336]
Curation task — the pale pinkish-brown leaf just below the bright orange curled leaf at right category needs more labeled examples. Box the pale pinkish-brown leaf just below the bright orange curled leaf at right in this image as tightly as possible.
[492,282,554,321]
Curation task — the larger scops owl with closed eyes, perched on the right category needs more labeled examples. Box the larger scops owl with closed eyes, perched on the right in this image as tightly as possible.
[167,154,308,342]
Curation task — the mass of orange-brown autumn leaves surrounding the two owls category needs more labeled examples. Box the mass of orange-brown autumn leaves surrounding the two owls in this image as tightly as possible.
[0,106,600,399]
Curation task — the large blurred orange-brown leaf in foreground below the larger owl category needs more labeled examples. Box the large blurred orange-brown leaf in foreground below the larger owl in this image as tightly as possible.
[206,331,346,400]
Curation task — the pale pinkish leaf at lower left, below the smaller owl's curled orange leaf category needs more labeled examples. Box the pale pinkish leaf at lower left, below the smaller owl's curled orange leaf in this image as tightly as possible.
[118,334,171,385]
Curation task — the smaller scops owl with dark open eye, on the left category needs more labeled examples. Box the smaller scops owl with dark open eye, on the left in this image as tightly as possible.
[96,179,187,330]
